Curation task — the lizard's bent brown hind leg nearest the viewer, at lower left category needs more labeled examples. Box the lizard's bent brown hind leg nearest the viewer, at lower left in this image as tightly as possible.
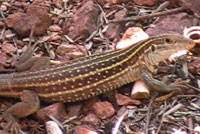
[4,90,40,131]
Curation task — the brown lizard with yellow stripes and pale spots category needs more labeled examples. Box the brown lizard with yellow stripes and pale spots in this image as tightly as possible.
[0,34,195,131]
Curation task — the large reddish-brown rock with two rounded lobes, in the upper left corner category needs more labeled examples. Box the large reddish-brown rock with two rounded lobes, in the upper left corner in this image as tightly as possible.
[5,1,51,37]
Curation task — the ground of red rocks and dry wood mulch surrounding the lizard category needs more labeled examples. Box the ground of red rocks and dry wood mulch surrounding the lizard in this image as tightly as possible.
[0,0,200,134]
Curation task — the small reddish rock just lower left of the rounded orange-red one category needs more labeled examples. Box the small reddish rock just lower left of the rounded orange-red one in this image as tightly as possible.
[81,113,100,126]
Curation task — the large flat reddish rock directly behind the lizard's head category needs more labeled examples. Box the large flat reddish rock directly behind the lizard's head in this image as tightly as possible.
[145,13,193,36]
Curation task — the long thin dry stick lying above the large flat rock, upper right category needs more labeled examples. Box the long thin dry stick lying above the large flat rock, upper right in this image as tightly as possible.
[109,7,186,23]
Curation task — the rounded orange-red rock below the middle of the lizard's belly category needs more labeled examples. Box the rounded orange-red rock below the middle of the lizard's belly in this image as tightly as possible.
[92,101,115,119]
